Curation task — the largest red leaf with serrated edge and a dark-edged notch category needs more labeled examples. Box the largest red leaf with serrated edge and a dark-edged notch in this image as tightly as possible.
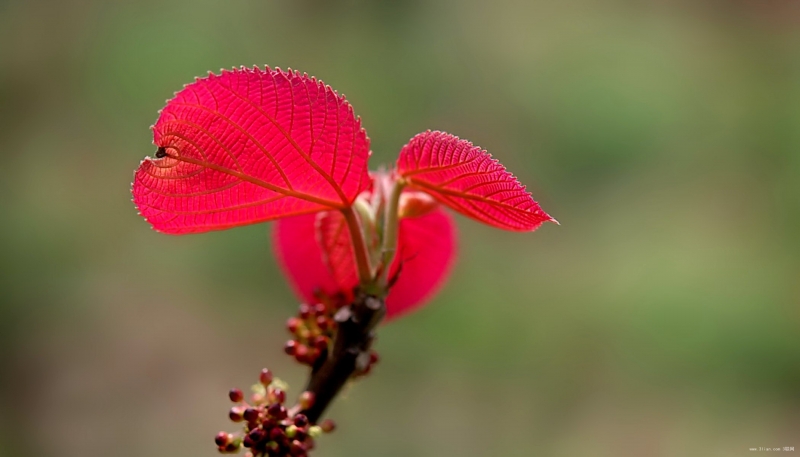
[133,68,369,234]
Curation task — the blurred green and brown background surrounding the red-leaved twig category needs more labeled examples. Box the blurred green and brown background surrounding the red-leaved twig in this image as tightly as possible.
[0,0,800,457]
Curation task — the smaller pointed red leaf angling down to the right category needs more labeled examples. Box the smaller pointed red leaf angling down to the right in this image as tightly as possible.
[397,130,555,231]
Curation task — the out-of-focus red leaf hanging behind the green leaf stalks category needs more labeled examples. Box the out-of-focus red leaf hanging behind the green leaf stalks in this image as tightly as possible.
[273,208,456,319]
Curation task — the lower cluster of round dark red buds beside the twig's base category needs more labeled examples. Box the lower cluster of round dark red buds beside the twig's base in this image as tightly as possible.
[214,369,335,457]
